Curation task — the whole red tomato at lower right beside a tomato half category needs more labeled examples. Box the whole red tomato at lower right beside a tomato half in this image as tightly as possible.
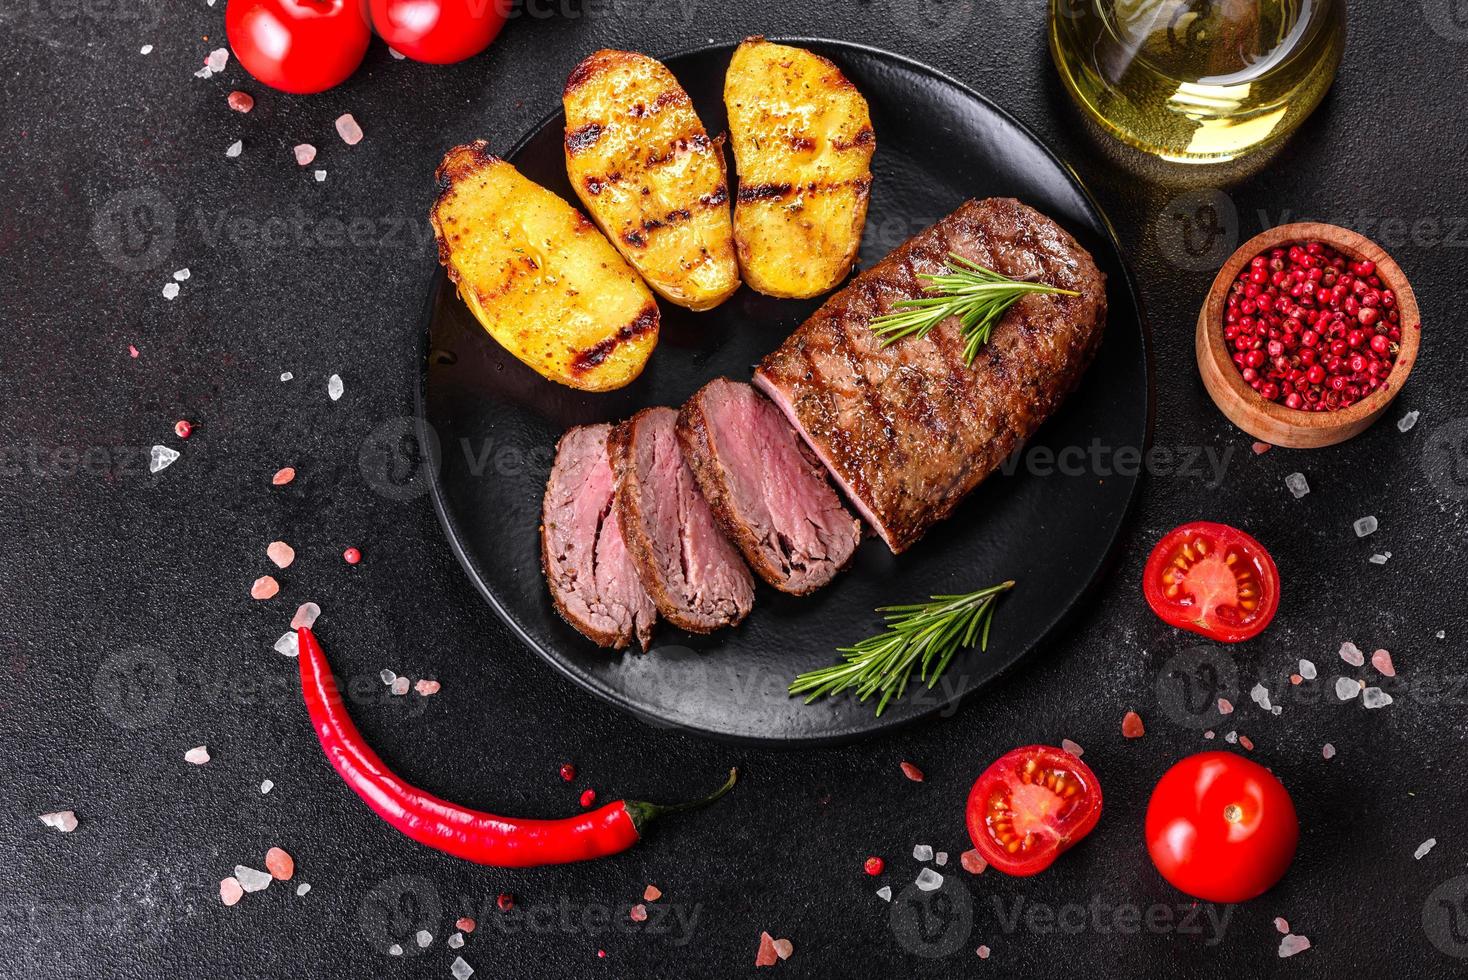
[1147,753,1299,902]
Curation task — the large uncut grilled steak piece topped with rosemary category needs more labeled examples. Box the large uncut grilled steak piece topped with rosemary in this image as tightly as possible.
[755,198,1105,553]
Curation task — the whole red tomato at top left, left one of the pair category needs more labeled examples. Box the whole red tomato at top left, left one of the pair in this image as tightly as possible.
[225,0,371,94]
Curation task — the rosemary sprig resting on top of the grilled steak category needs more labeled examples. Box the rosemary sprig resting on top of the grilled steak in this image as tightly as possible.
[872,252,1078,367]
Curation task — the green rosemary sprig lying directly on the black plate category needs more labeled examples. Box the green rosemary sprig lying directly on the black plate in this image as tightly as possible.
[790,581,1014,714]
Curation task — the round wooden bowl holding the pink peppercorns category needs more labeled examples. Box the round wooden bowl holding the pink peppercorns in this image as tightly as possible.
[1196,222,1422,449]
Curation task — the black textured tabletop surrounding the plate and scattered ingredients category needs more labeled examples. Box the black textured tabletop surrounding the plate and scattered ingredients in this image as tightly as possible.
[0,0,1468,977]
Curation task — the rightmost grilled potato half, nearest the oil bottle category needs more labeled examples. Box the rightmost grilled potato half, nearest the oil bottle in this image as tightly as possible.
[724,37,876,298]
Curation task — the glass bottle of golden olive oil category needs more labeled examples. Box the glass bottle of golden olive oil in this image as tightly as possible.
[1050,0,1346,163]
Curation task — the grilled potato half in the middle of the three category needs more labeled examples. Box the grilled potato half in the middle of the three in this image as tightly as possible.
[564,50,738,310]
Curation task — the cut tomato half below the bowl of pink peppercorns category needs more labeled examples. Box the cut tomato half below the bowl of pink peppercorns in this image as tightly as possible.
[1142,521,1280,643]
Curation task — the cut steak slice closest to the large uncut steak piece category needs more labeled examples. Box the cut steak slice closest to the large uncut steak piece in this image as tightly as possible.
[678,377,862,596]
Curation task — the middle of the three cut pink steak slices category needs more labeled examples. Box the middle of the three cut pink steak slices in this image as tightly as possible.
[608,408,755,632]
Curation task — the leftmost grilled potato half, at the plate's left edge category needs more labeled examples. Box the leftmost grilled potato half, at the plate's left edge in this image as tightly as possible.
[429,139,658,392]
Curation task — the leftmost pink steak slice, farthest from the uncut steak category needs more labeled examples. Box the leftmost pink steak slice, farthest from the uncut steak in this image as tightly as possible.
[540,425,658,650]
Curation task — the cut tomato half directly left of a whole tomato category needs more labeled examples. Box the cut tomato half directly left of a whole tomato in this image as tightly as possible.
[964,745,1101,877]
